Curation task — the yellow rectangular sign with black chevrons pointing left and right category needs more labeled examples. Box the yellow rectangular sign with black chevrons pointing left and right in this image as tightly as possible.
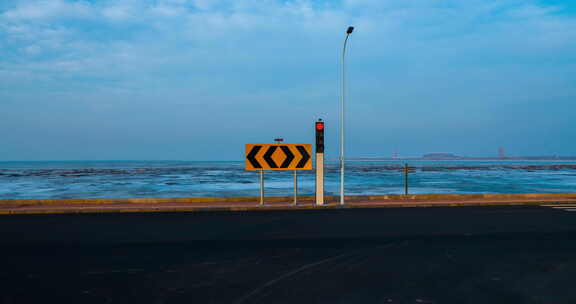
[246,144,312,171]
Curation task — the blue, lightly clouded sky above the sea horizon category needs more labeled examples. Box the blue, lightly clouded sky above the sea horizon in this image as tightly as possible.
[0,0,576,161]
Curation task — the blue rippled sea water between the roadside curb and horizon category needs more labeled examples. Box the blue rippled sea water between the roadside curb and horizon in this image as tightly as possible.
[0,161,576,199]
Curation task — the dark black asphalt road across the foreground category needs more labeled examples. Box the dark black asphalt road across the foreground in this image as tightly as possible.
[0,206,576,303]
